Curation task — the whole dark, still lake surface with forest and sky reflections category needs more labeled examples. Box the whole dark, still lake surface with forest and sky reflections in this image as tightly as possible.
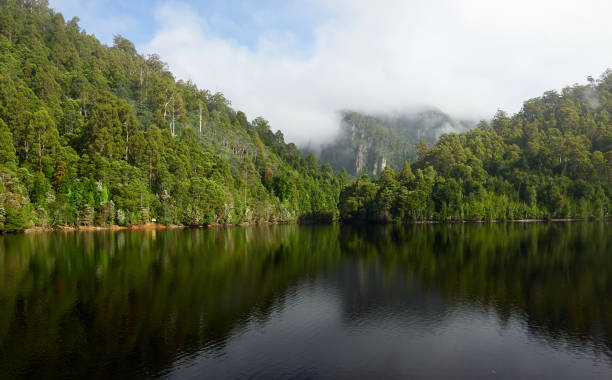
[0,223,612,379]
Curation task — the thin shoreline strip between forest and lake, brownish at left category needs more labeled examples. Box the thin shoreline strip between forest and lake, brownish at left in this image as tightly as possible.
[0,218,612,235]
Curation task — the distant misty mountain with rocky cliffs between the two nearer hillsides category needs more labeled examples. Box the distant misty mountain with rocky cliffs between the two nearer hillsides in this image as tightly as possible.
[320,108,476,176]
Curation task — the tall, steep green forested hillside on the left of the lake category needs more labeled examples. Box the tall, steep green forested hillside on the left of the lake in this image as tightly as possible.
[0,0,343,230]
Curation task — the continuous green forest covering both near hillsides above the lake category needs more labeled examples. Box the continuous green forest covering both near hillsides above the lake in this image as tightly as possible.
[0,0,612,231]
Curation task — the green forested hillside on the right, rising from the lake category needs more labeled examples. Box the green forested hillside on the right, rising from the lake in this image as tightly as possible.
[339,71,612,222]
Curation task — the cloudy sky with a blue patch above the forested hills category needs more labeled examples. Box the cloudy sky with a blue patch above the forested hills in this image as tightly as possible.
[50,0,612,144]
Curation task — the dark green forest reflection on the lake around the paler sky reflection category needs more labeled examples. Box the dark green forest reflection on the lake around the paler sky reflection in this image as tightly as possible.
[0,223,612,378]
